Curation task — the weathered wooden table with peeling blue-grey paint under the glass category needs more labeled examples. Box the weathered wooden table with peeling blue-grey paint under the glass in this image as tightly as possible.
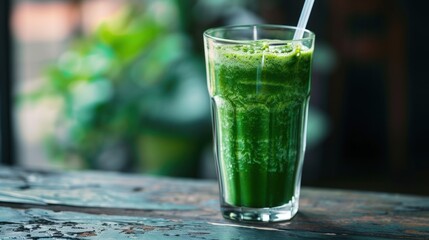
[0,167,429,240]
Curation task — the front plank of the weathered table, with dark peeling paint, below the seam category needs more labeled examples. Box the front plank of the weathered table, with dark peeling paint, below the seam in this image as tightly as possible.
[0,207,390,240]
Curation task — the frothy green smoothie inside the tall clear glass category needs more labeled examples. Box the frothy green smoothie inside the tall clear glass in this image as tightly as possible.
[208,43,313,208]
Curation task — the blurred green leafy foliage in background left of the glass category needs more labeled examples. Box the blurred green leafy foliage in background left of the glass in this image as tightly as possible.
[27,0,210,176]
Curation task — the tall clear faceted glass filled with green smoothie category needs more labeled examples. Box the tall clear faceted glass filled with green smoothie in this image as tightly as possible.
[204,25,315,222]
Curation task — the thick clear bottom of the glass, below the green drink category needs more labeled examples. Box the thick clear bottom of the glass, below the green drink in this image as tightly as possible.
[221,201,298,222]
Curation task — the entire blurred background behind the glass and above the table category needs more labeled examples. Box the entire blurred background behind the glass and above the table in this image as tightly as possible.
[0,0,429,195]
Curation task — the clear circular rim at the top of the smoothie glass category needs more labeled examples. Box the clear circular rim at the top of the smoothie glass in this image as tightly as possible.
[203,24,316,43]
